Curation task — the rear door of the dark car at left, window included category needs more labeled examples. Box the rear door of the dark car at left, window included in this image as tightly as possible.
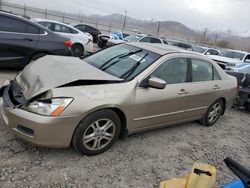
[0,15,40,66]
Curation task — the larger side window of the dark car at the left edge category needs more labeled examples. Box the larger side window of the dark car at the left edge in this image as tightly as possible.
[0,16,27,33]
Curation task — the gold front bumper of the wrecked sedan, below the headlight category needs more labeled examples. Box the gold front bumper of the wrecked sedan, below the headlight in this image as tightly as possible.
[0,98,81,147]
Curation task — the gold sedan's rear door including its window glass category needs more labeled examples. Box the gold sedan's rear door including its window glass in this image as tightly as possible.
[187,58,223,118]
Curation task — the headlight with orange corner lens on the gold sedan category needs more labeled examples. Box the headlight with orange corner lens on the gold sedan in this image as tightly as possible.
[22,98,73,116]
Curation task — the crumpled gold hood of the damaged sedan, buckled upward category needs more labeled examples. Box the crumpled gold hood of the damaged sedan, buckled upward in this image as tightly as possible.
[16,55,122,100]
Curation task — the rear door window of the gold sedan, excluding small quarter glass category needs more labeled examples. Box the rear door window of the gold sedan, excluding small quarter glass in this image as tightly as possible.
[192,59,213,82]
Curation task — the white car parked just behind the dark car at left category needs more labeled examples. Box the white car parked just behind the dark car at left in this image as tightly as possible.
[32,18,94,57]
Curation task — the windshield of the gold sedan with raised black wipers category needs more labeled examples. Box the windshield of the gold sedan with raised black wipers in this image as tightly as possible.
[84,44,160,81]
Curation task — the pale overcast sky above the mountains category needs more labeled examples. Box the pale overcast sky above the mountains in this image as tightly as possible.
[5,0,250,33]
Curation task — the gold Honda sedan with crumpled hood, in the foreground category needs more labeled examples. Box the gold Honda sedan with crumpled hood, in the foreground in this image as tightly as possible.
[0,43,237,155]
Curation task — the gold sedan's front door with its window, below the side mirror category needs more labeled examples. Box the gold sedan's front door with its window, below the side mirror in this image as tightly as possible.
[133,58,190,131]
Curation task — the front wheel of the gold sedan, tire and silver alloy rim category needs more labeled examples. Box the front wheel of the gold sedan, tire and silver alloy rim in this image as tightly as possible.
[72,110,121,155]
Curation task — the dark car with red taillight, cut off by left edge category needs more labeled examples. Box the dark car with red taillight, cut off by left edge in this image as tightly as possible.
[0,11,72,68]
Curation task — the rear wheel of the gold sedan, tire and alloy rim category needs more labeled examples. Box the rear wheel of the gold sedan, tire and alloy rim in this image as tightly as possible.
[200,99,224,126]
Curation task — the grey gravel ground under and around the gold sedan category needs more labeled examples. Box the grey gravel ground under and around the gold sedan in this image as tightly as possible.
[0,70,250,188]
